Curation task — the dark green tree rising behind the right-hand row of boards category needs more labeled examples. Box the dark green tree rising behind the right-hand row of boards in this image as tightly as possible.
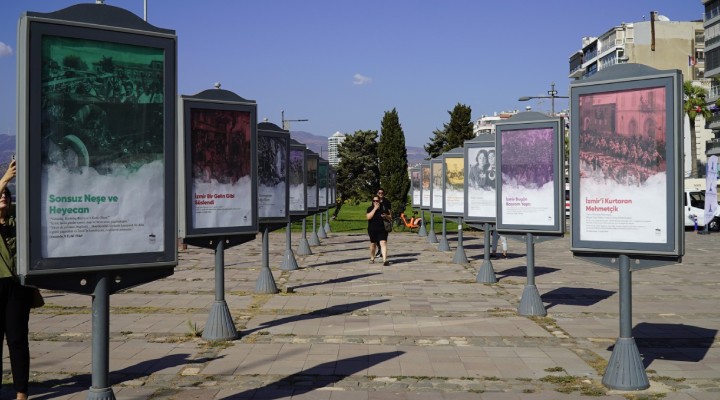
[424,103,475,158]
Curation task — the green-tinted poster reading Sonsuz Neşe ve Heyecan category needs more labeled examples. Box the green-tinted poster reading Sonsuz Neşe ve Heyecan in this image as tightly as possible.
[35,32,175,263]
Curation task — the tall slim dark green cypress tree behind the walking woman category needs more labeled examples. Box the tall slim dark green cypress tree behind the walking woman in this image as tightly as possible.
[377,108,410,217]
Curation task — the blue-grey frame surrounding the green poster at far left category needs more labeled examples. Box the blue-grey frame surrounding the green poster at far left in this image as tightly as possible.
[16,4,177,278]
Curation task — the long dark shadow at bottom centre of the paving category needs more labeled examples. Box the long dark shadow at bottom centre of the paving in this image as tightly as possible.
[217,351,405,400]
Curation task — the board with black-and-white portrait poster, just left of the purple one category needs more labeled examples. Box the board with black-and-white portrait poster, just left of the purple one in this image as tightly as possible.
[464,135,497,222]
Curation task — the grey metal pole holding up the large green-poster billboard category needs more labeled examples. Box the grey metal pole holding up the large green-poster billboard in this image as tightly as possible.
[88,271,115,400]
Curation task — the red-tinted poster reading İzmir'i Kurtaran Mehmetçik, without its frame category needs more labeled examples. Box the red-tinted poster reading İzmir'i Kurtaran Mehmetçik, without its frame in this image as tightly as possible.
[578,87,668,243]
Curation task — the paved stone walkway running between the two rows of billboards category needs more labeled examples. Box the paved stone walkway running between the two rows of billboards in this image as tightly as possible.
[0,227,720,400]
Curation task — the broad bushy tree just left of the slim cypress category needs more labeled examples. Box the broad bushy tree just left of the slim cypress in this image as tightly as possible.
[333,131,380,217]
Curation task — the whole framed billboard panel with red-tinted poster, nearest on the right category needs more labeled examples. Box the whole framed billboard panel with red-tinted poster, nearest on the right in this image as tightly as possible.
[570,66,684,256]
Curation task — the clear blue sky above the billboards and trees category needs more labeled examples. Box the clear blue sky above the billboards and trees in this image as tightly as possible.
[0,0,703,147]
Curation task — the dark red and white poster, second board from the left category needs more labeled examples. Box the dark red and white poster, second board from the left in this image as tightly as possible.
[189,107,253,229]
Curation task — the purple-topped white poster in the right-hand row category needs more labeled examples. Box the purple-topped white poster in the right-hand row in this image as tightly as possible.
[500,128,556,226]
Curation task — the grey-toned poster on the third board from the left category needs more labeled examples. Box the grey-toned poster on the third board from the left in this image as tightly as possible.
[258,130,290,222]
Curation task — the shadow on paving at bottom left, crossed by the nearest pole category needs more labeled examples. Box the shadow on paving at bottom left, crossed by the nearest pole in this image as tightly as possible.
[30,354,197,400]
